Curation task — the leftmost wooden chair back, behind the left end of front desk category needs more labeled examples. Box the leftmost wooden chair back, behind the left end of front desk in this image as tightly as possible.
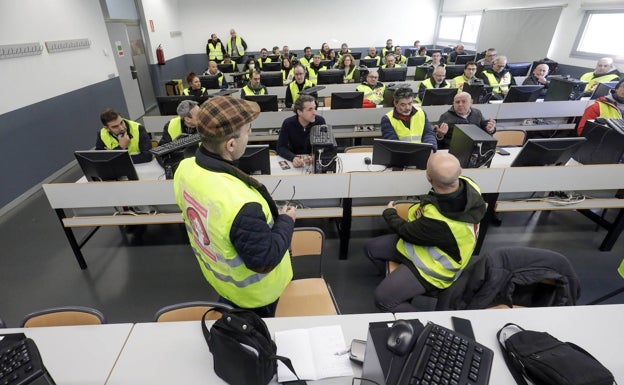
[20,306,106,328]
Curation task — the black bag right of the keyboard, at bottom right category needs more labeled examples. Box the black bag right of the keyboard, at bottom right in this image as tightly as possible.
[496,323,614,385]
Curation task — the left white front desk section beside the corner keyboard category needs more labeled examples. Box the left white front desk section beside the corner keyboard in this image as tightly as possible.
[0,323,133,385]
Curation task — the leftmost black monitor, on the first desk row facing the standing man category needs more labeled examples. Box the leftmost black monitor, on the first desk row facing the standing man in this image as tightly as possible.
[74,150,139,182]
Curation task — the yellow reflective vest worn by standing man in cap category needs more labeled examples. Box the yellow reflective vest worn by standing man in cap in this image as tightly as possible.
[174,158,292,308]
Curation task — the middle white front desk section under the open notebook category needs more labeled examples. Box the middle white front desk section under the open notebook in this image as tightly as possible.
[107,313,394,385]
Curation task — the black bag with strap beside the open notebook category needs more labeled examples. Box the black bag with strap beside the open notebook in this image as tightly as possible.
[201,307,305,385]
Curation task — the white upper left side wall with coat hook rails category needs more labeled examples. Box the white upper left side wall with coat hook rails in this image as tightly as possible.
[0,0,117,114]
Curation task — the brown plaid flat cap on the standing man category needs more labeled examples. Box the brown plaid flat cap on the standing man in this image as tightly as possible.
[197,96,260,138]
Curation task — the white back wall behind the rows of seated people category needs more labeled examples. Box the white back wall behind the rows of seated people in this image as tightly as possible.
[142,0,438,63]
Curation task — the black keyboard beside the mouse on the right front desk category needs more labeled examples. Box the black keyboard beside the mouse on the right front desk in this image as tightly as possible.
[398,322,494,385]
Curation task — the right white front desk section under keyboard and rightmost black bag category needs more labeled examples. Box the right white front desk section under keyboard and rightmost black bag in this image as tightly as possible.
[396,305,624,385]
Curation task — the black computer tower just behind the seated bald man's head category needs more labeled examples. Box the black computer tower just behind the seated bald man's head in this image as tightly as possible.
[449,124,496,168]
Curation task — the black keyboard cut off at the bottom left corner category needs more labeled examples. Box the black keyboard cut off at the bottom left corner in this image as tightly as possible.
[0,334,54,385]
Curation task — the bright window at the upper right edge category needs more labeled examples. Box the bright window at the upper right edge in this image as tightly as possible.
[573,11,624,59]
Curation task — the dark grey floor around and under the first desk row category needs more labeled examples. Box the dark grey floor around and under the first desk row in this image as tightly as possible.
[0,168,624,326]
